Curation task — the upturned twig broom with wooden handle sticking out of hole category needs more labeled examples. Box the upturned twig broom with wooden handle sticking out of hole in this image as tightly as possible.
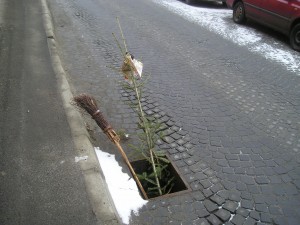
[73,94,148,199]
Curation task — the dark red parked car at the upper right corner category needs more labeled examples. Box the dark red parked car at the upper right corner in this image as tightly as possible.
[226,0,300,51]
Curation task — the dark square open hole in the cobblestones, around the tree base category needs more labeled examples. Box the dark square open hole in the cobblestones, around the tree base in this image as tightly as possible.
[131,157,191,199]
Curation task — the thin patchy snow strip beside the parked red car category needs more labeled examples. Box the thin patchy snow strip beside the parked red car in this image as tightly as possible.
[153,0,300,75]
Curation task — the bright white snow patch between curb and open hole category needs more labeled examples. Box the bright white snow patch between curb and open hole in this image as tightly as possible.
[95,147,148,224]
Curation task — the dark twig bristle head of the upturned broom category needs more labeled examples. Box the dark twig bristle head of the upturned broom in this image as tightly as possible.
[73,94,111,133]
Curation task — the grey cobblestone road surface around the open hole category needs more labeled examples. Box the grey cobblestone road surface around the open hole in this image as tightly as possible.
[49,0,300,225]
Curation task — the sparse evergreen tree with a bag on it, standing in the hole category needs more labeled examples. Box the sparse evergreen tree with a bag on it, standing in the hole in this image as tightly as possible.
[113,18,174,197]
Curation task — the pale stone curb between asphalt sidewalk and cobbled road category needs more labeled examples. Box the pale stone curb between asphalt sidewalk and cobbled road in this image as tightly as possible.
[41,0,122,225]
